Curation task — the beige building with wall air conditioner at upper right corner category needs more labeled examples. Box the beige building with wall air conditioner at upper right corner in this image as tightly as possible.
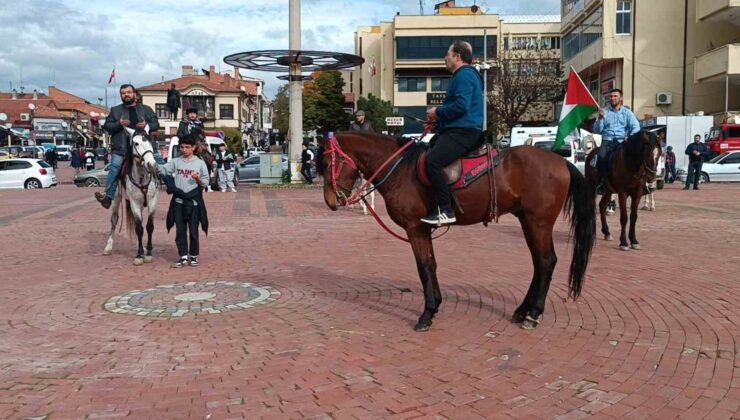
[561,0,740,119]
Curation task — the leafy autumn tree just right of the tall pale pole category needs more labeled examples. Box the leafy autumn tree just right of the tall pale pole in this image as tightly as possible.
[303,70,351,133]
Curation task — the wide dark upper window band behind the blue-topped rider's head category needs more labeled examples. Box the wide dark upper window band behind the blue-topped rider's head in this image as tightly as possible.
[396,35,498,60]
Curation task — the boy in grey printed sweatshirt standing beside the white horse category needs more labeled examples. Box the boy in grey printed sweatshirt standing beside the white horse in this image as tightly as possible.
[159,135,210,268]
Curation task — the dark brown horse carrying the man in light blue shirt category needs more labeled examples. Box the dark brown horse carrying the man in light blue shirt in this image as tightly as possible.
[586,130,663,251]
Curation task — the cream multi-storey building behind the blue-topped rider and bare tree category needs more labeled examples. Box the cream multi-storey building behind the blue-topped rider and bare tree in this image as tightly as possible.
[352,1,560,131]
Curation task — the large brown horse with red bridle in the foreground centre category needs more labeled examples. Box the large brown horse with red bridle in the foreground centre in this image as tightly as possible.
[318,133,596,331]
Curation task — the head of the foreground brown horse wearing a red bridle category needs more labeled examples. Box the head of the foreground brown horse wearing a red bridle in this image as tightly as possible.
[316,137,359,210]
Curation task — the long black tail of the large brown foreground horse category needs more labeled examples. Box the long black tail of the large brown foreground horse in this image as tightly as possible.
[564,162,596,299]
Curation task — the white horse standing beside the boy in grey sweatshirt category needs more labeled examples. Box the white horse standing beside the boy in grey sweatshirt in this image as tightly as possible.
[103,127,159,265]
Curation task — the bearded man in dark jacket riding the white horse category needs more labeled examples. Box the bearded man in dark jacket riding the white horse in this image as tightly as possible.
[95,84,159,209]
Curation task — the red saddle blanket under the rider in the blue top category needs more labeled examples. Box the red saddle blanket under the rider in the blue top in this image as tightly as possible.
[416,149,499,190]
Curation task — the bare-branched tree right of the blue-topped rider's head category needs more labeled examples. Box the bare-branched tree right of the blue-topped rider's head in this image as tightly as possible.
[488,50,565,138]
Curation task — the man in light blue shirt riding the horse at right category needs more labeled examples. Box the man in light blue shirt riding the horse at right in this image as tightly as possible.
[594,89,640,194]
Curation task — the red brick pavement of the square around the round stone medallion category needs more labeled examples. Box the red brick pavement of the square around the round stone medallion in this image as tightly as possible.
[0,180,740,419]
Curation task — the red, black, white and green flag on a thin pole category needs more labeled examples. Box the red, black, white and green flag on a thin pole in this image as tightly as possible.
[552,66,599,150]
